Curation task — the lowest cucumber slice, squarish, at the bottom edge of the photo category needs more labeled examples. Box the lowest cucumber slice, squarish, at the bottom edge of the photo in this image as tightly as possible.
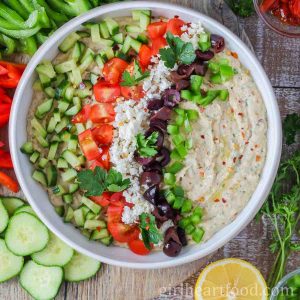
[20,260,64,300]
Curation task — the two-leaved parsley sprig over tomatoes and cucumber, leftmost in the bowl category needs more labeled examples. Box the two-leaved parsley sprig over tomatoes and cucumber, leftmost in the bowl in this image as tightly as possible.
[77,166,130,197]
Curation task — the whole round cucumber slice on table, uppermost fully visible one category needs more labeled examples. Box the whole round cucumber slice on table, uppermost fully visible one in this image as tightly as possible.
[5,212,49,256]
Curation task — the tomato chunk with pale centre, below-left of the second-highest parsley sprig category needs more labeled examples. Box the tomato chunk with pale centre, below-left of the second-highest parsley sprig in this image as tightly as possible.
[93,81,121,103]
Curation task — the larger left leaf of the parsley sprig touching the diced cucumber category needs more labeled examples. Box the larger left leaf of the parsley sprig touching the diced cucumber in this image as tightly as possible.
[77,167,107,196]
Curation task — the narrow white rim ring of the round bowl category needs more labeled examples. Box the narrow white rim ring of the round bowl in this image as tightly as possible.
[9,1,282,269]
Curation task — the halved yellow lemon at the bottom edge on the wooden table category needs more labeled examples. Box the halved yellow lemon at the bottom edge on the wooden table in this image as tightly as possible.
[195,258,268,300]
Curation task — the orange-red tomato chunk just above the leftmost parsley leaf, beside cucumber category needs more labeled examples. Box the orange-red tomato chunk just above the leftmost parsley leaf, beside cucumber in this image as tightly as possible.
[78,129,102,160]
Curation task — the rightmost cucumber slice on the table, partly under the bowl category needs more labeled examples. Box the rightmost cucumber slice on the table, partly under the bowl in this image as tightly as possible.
[64,252,101,282]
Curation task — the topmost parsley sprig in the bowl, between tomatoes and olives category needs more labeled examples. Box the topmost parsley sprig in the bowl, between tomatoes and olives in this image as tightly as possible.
[159,32,196,69]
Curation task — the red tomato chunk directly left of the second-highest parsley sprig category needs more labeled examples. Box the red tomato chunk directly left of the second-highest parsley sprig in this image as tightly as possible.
[102,57,128,84]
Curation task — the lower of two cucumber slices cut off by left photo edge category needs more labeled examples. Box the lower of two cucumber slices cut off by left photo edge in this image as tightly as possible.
[0,239,24,283]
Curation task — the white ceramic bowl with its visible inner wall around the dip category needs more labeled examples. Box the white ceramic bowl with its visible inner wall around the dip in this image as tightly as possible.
[9,2,281,269]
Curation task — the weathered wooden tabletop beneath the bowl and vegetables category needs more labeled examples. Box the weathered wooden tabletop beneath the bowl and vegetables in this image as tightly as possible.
[0,0,300,300]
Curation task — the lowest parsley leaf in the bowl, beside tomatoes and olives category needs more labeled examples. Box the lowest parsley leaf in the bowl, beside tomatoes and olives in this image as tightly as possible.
[140,213,162,250]
